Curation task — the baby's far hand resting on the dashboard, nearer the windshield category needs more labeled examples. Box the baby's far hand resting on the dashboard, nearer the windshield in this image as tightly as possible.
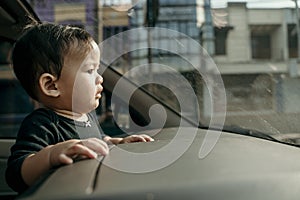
[104,134,154,144]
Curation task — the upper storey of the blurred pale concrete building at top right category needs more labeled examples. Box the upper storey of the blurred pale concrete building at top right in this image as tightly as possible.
[214,2,297,69]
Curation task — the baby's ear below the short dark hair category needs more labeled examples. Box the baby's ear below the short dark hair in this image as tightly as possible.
[39,73,60,97]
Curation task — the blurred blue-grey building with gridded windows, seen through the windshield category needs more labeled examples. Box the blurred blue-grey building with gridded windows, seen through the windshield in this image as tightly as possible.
[130,0,200,69]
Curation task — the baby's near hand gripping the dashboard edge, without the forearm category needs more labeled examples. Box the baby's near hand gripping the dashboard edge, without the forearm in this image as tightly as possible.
[49,138,109,166]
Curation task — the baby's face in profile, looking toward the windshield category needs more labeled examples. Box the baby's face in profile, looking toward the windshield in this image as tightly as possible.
[56,41,103,113]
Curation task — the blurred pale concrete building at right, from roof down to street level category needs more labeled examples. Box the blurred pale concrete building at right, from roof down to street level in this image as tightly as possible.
[202,2,300,114]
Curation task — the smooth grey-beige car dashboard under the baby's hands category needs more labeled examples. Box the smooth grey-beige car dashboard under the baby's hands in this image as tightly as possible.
[20,127,300,199]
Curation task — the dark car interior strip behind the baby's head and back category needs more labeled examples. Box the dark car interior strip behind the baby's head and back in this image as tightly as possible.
[0,1,38,199]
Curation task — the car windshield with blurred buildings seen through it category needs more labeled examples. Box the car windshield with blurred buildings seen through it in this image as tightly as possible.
[0,0,300,144]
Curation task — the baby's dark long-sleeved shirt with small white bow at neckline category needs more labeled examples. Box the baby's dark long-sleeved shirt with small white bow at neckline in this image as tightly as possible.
[6,108,104,192]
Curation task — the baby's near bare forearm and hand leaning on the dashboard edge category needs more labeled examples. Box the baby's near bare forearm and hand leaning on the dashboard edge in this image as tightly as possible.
[21,138,109,186]
